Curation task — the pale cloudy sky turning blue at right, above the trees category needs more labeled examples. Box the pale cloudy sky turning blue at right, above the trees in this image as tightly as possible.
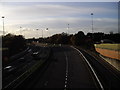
[0,2,118,38]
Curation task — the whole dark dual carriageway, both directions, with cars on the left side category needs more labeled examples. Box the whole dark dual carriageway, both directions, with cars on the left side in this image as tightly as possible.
[3,45,120,90]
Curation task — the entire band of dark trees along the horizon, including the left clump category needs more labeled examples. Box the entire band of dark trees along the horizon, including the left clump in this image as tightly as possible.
[2,31,120,65]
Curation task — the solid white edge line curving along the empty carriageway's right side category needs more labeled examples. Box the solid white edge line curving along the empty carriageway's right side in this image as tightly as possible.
[71,46,104,90]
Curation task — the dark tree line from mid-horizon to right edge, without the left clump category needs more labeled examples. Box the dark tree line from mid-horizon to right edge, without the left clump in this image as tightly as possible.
[28,31,120,50]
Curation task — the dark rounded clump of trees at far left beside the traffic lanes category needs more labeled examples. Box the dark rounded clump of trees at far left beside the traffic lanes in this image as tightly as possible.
[2,34,27,59]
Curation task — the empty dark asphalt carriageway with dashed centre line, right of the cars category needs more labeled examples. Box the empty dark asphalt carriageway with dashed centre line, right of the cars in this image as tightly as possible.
[19,46,100,89]
